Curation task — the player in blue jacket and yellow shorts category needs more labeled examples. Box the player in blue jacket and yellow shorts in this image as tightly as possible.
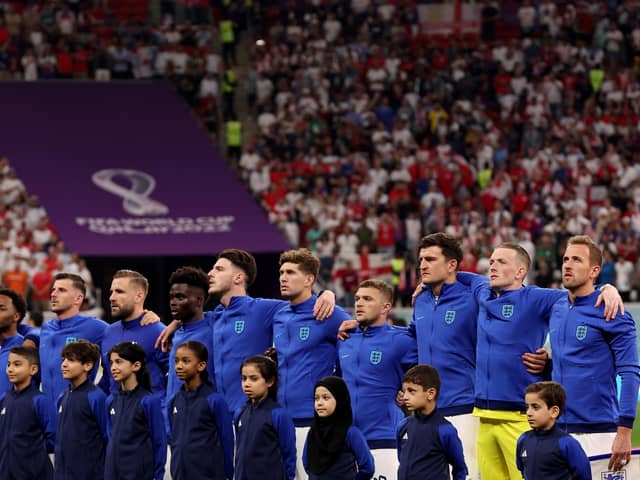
[458,243,619,479]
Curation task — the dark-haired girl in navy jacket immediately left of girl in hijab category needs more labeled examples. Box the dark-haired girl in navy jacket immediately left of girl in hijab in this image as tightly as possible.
[234,355,296,480]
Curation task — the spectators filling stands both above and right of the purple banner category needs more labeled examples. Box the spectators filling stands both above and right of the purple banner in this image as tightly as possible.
[0,0,640,304]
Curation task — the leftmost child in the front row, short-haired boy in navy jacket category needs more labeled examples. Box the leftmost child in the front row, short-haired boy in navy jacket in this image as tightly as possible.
[0,346,55,480]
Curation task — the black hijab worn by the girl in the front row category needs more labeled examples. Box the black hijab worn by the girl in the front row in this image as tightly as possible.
[307,377,353,475]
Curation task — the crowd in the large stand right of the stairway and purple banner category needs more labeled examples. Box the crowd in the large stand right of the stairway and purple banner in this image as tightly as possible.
[234,1,640,298]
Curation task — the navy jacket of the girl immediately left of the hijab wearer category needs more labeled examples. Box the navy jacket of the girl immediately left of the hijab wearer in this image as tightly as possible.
[235,398,296,480]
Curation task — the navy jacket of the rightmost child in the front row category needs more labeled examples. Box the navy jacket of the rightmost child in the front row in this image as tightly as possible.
[516,426,592,480]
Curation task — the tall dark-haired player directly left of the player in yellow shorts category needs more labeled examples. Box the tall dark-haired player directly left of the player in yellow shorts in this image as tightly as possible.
[409,233,479,478]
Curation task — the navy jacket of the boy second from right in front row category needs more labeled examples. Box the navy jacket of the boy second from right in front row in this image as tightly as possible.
[397,408,468,480]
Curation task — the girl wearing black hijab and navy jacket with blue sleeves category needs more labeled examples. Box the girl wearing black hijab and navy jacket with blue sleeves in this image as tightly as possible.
[302,377,375,480]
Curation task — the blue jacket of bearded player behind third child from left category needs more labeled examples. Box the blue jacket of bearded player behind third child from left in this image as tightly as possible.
[100,315,169,397]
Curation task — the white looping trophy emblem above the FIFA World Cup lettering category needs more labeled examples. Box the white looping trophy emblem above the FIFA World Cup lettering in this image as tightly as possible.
[91,168,169,217]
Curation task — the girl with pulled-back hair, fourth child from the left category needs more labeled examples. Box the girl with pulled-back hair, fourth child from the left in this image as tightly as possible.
[168,341,233,480]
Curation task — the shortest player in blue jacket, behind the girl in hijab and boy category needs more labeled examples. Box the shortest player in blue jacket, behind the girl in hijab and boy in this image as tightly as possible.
[338,280,418,479]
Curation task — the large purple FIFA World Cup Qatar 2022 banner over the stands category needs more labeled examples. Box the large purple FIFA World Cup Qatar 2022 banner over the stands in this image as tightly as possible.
[0,83,290,255]
